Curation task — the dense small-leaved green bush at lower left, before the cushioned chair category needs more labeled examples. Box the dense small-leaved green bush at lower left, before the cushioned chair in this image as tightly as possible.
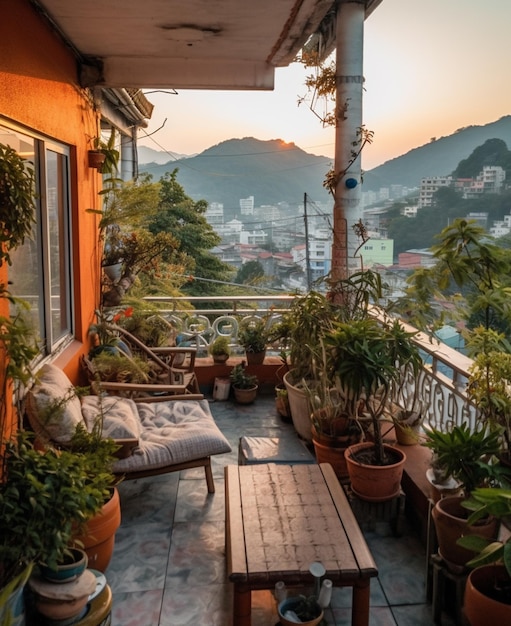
[0,433,117,588]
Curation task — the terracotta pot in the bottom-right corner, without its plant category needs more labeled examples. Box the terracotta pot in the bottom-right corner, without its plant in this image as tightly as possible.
[463,565,511,626]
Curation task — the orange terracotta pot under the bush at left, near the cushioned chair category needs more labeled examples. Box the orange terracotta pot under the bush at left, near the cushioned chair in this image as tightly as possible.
[77,489,121,572]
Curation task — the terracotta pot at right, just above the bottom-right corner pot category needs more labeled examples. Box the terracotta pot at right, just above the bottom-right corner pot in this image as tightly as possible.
[431,496,498,569]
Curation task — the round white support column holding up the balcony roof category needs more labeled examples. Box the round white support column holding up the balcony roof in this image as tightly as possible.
[332,0,365,279]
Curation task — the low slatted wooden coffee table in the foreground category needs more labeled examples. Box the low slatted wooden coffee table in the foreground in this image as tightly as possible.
[225,463,378,626]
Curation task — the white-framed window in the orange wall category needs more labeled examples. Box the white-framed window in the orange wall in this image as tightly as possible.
[0,124,73,356]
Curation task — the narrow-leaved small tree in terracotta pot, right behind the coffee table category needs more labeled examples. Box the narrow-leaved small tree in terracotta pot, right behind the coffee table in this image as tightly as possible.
[323,317,422,501]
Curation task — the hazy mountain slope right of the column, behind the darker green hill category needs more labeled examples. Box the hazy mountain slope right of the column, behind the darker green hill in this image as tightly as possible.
[363,115,511,191]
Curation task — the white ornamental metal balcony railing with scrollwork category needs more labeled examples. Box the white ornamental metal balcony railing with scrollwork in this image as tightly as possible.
[146,295,477,429]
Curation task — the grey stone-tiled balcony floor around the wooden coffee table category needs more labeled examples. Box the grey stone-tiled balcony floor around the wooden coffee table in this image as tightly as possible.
[106,396,452,626]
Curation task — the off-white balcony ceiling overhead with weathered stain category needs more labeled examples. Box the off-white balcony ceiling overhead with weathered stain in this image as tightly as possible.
[32,0,382,89]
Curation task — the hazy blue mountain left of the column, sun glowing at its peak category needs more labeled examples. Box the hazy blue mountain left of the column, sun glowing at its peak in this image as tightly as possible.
[139,137,332,211]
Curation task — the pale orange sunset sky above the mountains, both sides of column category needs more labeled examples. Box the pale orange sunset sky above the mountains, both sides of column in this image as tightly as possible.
[139,0,511,171]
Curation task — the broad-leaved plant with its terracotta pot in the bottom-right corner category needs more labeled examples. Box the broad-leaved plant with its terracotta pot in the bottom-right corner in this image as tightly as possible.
[458,488,511,626]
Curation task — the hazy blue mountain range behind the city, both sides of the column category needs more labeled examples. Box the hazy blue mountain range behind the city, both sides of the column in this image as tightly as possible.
[139,115,511,204]
